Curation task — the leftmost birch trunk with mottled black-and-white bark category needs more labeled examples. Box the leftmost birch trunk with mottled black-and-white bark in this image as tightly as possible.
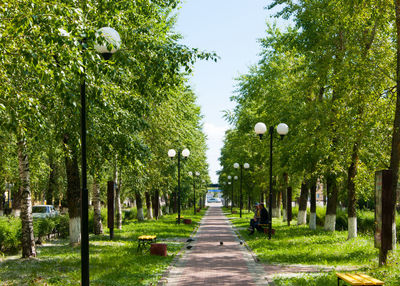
[18,139,36,258]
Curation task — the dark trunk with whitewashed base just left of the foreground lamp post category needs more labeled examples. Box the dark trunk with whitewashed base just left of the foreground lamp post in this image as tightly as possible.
[64,136,81,245]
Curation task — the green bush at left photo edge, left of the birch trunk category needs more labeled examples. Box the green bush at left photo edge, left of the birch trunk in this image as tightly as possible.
[0,217,21,253]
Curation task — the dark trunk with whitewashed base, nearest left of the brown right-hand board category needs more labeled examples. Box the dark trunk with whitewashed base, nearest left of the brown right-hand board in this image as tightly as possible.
[347,142,358,239]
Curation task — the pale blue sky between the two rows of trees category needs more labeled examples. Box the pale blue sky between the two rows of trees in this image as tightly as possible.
[175,0,285,183]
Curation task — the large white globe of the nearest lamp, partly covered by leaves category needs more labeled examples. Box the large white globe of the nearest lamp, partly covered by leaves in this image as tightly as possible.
[94,27,121,54]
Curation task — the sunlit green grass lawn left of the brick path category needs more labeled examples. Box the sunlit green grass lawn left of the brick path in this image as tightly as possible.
[0,210,205,286]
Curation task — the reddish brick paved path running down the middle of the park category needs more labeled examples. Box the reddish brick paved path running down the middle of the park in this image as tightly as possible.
[167,207,268,286]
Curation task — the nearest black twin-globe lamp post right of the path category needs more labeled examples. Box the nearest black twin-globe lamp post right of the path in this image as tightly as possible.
[254,122,289,239]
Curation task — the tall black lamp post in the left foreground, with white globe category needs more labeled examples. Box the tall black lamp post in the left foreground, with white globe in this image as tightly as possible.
[80,27,121,286]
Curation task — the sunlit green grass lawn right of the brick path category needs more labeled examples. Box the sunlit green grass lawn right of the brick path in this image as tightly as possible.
[224,209,400,286]
